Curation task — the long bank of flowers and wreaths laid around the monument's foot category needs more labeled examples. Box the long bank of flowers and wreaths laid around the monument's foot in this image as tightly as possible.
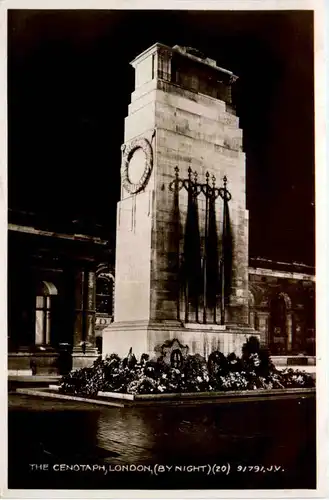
[59,337,315,396]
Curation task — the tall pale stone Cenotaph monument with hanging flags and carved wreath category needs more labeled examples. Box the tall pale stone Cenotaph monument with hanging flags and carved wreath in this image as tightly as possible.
[103,43,254,356]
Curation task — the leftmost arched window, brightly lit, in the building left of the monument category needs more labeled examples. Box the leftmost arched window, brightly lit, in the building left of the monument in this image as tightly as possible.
[35,281,58,345]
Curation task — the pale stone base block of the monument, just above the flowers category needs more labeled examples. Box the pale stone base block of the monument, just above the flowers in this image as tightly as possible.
[102,321,260,359]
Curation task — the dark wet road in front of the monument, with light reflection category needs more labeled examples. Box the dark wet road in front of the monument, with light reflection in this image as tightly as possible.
[8,394,316,489]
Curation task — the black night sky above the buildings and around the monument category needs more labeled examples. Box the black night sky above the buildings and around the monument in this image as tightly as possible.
[8,11,315,265]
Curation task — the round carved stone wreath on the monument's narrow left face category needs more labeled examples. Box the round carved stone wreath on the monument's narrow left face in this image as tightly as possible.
[121,138,153,194]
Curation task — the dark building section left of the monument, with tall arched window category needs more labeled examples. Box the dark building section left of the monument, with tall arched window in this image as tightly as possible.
[8,211,112,374]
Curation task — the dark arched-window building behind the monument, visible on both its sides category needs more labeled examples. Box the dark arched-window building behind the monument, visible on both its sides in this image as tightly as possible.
[8,217,316,374]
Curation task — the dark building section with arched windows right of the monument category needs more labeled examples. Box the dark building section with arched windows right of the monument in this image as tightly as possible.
[249,258,316,357]
